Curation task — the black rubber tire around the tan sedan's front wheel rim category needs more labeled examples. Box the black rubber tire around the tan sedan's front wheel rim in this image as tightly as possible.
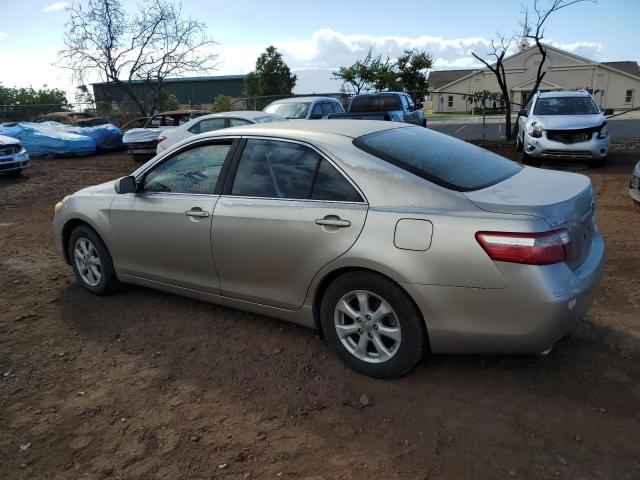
[67,225,119,295]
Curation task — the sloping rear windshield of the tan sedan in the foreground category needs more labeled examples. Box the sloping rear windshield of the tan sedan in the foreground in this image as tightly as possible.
[353,127,521,192]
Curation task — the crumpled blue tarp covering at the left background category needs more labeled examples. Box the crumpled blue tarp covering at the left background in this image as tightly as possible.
[0,122,122,156]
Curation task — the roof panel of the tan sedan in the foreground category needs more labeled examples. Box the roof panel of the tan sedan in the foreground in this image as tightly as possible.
[200,119,408,139]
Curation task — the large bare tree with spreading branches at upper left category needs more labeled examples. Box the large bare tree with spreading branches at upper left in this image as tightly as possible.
[58,0,217,115]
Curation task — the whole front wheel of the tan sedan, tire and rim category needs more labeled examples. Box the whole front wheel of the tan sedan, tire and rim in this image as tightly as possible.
[67,225,118,295]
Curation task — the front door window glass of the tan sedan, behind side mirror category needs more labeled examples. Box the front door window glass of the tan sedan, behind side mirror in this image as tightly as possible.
[143,142,231,195]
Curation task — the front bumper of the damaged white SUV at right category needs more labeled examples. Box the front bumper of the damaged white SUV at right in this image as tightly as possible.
[523,132,609,160]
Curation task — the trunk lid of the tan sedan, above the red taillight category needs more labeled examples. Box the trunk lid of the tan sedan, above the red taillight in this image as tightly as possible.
[465,167,595,269]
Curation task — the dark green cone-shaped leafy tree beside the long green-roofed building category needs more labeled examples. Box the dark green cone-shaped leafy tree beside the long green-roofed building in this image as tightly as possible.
[244,45,298,108]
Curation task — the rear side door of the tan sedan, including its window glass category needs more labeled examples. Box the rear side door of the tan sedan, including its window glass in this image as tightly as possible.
[212,138,367,309]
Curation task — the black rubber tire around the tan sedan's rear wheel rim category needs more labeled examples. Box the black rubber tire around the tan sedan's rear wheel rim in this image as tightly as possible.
[320,272,427,379]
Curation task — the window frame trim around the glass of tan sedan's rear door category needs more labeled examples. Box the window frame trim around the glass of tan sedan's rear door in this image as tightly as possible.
[222,136,369,205]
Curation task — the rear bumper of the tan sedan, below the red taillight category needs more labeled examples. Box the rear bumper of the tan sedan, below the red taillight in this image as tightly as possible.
[403,232,604,354]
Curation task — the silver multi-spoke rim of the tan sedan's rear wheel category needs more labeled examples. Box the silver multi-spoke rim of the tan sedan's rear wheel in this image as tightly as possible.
[333,290,402,363]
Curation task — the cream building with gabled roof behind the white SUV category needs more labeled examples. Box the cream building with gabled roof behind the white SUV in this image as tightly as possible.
[428,41,640,113]
